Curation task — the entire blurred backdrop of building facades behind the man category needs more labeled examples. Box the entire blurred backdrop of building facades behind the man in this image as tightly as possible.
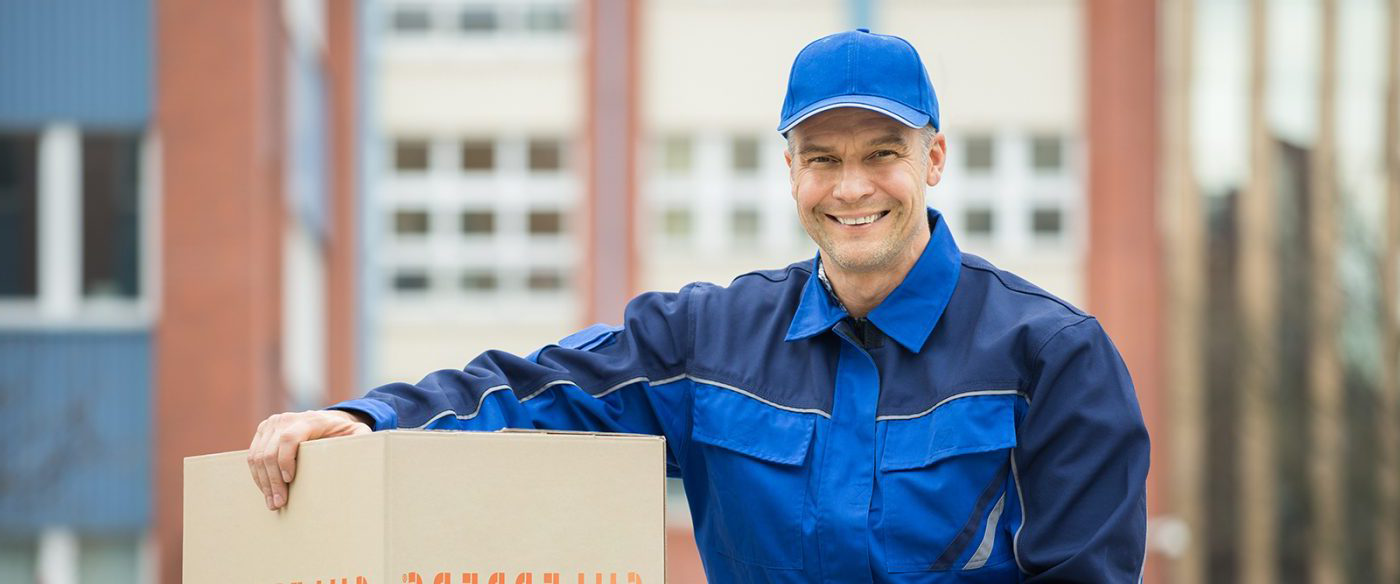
[0,0,1400,584]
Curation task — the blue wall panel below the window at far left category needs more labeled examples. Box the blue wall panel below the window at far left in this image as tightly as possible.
[0,331,153,535]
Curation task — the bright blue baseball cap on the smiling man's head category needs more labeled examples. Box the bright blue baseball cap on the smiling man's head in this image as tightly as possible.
[778,28,939,136]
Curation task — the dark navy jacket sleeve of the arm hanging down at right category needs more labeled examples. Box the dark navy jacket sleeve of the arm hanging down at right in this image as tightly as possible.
[1012,318,1148,583]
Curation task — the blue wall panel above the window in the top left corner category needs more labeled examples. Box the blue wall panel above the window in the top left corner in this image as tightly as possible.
[0,0,154,126]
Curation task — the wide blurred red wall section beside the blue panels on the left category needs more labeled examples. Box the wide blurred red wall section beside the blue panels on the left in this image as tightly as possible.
[154,0,286,583]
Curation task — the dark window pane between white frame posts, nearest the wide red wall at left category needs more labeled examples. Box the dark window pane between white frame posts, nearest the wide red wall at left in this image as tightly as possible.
[83,133,141,298]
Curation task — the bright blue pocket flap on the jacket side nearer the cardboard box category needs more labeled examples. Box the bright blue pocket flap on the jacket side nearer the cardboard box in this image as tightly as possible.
[690,382,816,465]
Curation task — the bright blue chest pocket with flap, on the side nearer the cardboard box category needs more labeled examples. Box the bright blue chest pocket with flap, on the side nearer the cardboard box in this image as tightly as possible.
[692,382,815,569]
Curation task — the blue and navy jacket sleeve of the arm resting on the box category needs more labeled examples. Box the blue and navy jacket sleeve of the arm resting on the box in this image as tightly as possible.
[330,284,697,467]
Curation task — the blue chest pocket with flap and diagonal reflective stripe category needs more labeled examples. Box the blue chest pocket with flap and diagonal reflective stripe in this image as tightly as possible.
[879,392,1023,571]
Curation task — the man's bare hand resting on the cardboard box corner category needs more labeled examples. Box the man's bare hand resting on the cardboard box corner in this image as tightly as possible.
[248,410,374,510]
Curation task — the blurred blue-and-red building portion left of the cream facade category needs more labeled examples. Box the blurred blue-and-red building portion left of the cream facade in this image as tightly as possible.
[0,0,361,584]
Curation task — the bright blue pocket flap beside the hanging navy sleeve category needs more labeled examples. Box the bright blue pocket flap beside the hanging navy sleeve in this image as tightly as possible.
[881,392,1022,471]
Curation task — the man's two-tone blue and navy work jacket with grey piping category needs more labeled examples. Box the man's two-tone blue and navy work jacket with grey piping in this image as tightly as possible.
[335,210,1148,583]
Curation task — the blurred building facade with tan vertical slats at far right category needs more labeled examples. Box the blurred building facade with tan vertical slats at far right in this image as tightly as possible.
[1148,0,1400,583]
